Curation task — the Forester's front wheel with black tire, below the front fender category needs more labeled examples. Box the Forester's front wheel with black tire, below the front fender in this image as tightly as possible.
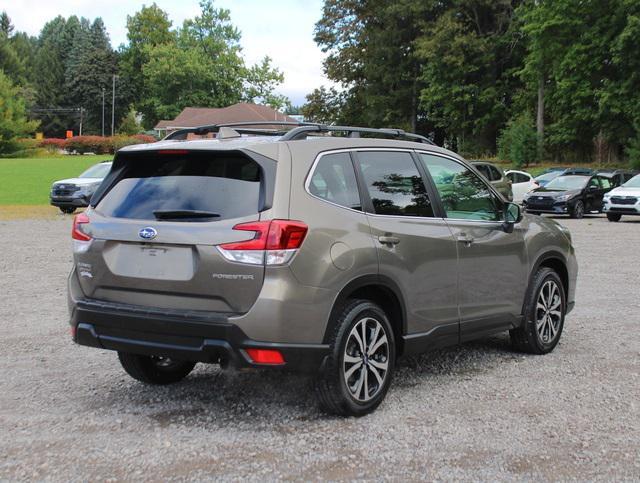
[509,267,567,354]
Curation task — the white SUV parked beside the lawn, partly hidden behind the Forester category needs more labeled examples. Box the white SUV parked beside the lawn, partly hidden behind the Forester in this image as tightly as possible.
[50,161,112,213]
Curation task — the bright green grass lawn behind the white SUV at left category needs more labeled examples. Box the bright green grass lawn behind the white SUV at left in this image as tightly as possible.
[0,155,113,206]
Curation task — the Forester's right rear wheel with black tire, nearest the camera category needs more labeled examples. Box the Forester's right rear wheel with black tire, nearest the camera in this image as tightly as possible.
[315,300,396,416]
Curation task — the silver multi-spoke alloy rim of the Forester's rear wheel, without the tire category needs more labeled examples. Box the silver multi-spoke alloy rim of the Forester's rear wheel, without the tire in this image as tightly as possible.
[342,317,389,402]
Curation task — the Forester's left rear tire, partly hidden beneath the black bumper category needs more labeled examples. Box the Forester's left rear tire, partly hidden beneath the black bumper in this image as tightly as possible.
[118,352,196,385]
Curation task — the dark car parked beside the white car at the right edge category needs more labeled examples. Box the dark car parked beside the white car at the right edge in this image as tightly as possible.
[522,174,612,218]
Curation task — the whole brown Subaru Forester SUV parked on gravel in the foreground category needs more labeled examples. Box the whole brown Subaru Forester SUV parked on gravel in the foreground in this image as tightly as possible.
[68,121,577,416]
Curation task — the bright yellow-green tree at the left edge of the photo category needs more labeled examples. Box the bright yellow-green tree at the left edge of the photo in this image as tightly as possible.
[0,70,38,154]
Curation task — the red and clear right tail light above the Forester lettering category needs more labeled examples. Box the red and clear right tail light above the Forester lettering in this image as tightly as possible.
[217,220,308,265]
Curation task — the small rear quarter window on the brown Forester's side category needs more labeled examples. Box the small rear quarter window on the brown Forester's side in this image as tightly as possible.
[309,153,362,210]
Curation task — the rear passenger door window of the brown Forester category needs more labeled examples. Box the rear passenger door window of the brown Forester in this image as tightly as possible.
[358,151,433,216]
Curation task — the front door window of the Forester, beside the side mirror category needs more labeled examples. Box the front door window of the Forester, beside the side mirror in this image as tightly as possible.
[421,154,502,221]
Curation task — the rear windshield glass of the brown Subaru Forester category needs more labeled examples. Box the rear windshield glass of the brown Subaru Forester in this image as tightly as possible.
[96,152,262,221]
